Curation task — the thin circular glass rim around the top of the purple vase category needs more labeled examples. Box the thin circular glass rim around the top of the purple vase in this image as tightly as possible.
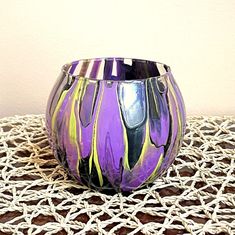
[61,57,171,82]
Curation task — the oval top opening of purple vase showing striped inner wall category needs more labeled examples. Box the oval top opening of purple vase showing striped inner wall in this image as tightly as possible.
[62,58,170,81]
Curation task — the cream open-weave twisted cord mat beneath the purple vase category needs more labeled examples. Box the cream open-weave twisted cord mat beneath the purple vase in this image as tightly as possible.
[0,115,235,235]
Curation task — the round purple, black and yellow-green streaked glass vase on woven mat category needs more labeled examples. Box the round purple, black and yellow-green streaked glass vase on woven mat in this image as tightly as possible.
[46,58,186,191]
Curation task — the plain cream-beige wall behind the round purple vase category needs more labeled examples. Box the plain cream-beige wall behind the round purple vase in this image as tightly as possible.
[0,0,235,117]
